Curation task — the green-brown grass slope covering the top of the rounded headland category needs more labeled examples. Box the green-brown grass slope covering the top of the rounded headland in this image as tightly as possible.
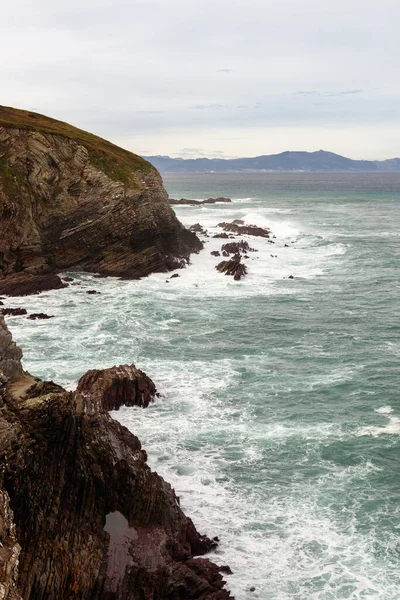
[0,106,154,183]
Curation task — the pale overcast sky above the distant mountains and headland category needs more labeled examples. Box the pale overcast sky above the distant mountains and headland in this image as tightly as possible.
[0,0,400,159]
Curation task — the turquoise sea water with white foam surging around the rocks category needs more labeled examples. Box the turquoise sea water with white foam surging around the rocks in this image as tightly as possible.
[8,173,400,600]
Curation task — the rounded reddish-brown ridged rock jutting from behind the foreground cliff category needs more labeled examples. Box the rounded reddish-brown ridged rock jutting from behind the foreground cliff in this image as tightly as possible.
[77,365,157,410]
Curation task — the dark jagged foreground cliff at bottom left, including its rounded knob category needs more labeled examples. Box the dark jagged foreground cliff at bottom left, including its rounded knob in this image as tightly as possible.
[0,316,230,600]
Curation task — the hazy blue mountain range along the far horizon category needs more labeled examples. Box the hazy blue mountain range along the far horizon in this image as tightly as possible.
[143,150,400,173]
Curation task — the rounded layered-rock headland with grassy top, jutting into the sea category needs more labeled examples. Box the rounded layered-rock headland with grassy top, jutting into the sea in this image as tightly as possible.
[0,106,202,295]
